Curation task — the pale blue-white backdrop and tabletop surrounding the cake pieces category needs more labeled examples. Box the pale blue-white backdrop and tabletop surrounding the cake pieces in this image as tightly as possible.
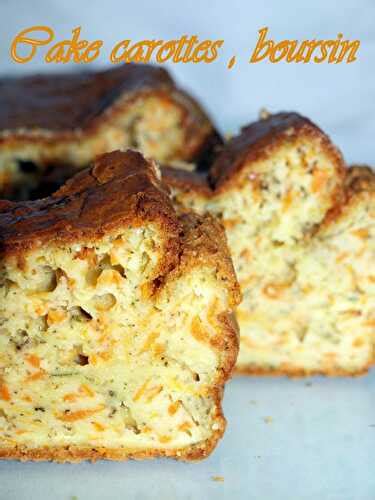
[0,0,375,500]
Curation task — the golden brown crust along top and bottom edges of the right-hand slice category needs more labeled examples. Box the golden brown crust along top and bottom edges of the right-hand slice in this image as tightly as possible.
[162,113,375,377]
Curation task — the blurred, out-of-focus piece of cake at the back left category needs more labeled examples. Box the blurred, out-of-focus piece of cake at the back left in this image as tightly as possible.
[0,64,220,199]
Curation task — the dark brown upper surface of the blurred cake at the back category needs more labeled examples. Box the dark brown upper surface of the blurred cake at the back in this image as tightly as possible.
[0,64,175,131]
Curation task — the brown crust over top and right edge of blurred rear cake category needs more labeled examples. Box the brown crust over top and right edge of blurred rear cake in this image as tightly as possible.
[0,64,221,161]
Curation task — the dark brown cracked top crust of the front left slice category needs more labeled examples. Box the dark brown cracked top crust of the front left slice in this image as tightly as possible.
[0,150,180,258]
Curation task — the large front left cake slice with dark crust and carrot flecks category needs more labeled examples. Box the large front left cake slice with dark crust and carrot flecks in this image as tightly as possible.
[0,151,239,461]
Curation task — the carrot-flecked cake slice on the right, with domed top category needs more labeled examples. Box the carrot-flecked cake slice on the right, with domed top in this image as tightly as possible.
[164,113,375,375]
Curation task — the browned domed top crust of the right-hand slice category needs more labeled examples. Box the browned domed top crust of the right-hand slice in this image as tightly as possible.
[210,112,343,189]
